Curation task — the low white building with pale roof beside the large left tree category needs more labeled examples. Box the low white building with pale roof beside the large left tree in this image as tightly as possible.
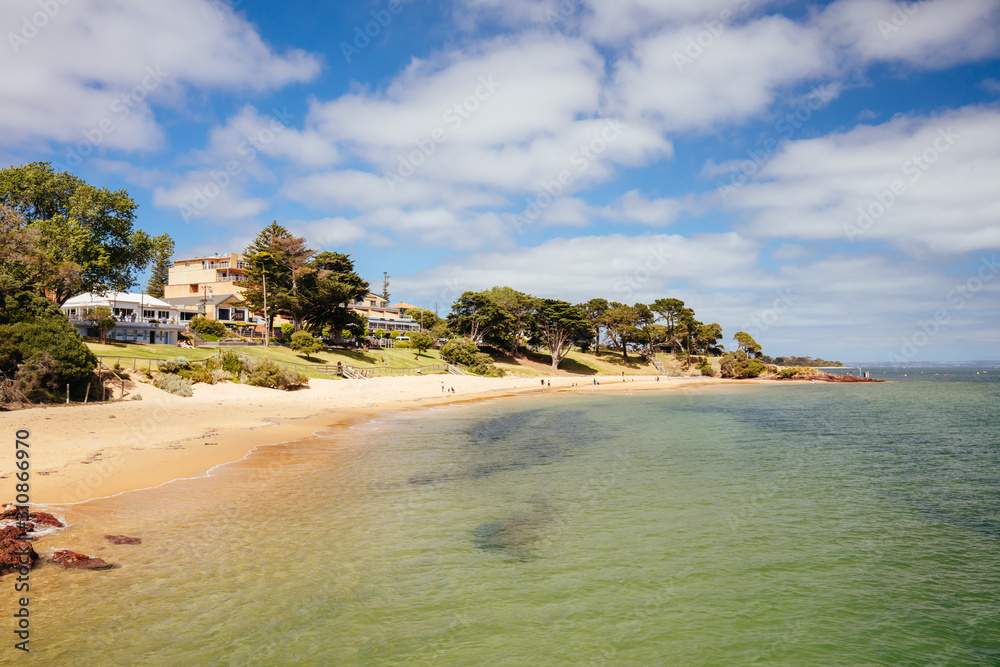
[60,292,185,345]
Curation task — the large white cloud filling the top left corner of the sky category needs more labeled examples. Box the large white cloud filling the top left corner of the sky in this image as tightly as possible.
[0,0,319,151]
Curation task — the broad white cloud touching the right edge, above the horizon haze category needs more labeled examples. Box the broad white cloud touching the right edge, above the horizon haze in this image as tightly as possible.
[730,107,1000,253]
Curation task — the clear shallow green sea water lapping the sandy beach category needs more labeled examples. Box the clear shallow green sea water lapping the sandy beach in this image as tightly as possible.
[15,369,1000,665]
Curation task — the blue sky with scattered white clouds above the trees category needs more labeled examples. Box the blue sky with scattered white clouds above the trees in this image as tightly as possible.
[0,0,1000,361]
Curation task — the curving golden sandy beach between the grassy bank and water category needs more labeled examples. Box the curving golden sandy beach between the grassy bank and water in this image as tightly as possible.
[0,375,728,505]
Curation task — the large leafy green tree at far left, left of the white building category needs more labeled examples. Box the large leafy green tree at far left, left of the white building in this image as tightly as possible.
[0,162,153,303]
